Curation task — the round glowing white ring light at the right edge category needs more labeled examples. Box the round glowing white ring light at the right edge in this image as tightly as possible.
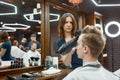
[105,21,120,38]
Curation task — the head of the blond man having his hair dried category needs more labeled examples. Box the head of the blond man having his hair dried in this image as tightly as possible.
[76,25,106,59]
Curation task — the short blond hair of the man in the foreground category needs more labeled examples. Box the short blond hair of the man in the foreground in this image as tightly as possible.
[81,25,106,57]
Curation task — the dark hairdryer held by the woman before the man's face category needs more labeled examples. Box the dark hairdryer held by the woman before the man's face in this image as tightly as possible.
[57,36,79,55]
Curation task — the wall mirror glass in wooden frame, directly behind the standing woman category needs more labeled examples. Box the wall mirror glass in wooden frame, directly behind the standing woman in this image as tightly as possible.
[50,1,82,56]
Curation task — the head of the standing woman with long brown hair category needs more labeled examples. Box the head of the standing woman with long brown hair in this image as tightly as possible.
[58,13,77,38]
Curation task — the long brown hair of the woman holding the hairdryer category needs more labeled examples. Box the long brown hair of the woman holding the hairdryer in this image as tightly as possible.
[58,13,77,39]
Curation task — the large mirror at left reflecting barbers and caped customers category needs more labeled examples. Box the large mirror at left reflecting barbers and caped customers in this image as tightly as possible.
[0,0,41,68]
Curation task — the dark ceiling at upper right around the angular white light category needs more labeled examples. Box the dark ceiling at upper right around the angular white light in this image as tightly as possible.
[59,0,120,24]
